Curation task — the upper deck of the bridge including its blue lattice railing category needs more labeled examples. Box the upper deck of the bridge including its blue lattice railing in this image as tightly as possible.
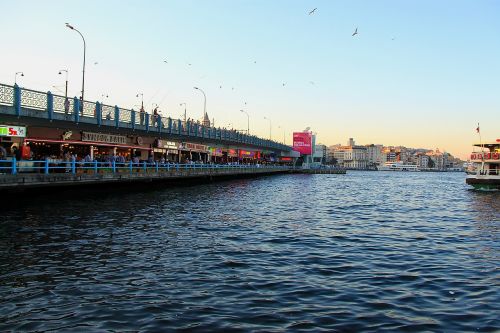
[0,84,292,156]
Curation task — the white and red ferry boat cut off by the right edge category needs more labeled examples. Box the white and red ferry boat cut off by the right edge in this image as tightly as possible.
[465,139,500,191]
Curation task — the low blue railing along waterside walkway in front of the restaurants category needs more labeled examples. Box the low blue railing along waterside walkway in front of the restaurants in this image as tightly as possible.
[0,158,290,175]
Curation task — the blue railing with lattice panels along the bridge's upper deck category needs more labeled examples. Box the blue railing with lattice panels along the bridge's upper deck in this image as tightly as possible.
[0,84,291,151]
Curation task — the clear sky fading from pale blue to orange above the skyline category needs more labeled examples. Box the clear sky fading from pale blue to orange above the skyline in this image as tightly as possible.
[0,0,500,159]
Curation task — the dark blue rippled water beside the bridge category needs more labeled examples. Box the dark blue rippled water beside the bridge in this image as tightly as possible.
[0,172,500,332]
